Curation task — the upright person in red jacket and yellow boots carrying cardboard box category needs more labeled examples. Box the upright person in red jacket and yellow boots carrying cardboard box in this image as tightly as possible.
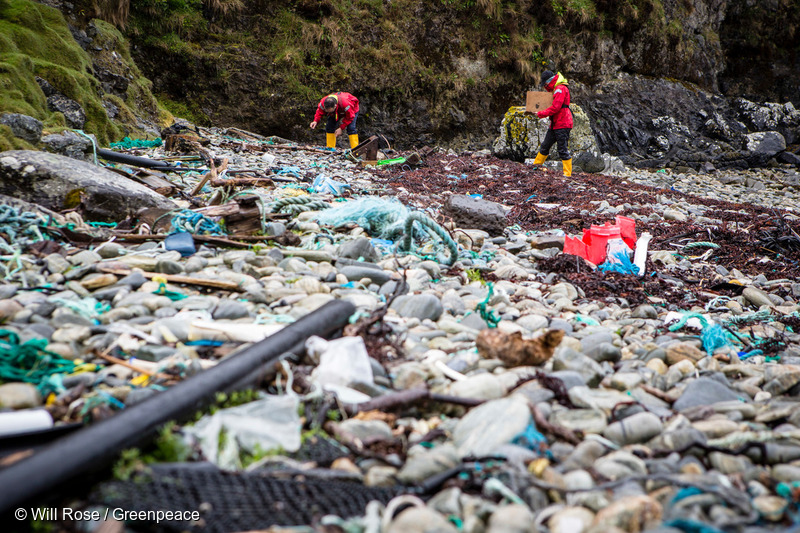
[533,70,572,176]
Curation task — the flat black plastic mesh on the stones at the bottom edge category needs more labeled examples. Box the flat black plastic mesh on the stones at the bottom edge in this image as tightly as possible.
[93,464,399,533]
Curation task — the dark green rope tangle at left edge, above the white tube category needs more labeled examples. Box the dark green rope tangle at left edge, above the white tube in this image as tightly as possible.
[0,329,75,385]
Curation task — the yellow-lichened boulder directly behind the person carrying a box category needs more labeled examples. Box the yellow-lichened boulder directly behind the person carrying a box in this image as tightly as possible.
[492,104,598,162]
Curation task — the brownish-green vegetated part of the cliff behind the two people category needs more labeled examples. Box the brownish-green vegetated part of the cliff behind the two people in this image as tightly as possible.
[112,0,680,144]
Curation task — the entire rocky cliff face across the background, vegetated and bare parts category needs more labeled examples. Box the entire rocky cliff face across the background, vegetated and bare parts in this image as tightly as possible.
[15,0,800,166]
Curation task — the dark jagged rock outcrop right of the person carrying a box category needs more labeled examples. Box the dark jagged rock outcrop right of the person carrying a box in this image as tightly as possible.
[576,74,800,169]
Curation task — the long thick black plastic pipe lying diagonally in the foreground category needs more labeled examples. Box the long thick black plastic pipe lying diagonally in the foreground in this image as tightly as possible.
[0,300,355,515]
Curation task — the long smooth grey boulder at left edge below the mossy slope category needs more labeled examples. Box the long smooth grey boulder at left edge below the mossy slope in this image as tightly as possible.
[0,150,177,221]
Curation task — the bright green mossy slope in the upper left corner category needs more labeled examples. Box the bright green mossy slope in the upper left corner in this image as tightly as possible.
[0,0,169,150]
